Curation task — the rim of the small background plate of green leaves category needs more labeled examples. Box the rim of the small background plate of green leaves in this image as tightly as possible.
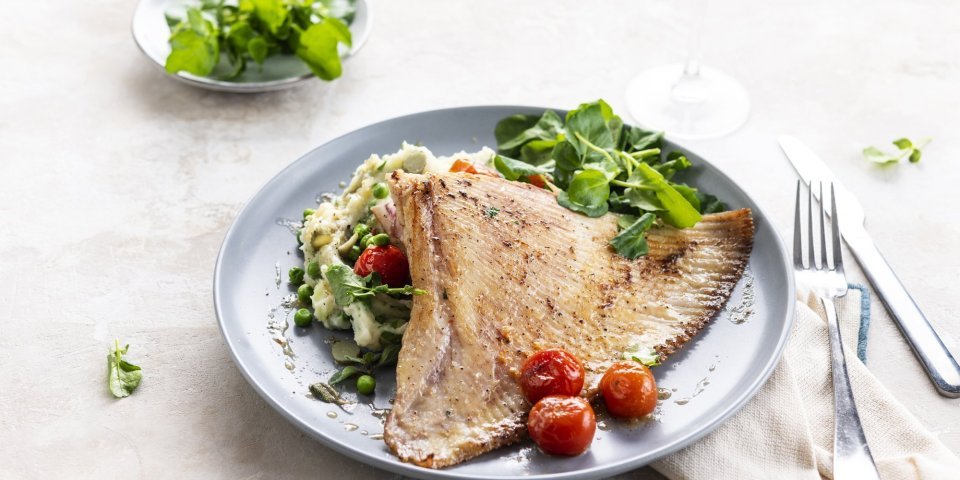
[130,0,373,93]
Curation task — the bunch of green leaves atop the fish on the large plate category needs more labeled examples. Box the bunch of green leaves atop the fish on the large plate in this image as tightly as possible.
[494,100,726,259]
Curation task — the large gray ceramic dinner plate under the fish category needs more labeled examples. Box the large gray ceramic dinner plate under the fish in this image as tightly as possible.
[214,106,794,478]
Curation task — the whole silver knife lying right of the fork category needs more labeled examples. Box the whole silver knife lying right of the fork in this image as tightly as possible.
[778,135,960,398]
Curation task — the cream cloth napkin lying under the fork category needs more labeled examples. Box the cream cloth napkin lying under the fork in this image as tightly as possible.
[652,289,960,480]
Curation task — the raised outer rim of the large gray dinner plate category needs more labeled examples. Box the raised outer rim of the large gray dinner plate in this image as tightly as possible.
[213,105,796,480]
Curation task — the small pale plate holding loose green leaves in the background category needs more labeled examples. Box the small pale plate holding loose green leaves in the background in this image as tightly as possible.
[131,0,371,93]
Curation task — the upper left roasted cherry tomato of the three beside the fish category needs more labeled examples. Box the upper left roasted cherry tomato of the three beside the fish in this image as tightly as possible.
[520,349,584,403]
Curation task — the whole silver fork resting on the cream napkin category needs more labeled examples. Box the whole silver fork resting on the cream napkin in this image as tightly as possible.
[793,181,880,480]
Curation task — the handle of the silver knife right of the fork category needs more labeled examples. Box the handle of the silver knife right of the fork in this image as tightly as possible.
[844,230,960,398]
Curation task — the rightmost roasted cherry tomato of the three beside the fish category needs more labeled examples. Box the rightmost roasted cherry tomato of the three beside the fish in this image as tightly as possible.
[600,362,657,418]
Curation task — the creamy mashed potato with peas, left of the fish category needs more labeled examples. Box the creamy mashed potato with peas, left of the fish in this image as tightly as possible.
[301,142,495,350]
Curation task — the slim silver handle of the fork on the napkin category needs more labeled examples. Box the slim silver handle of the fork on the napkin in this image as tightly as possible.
[820,297,880,480]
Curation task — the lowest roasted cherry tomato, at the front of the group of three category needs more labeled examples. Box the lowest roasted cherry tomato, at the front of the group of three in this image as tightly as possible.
[527,395,597,456]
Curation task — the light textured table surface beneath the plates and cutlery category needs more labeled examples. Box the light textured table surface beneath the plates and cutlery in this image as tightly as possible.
[0,0,960,478]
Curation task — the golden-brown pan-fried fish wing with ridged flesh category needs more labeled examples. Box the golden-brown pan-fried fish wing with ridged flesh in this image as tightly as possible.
[384,172,753,468]
